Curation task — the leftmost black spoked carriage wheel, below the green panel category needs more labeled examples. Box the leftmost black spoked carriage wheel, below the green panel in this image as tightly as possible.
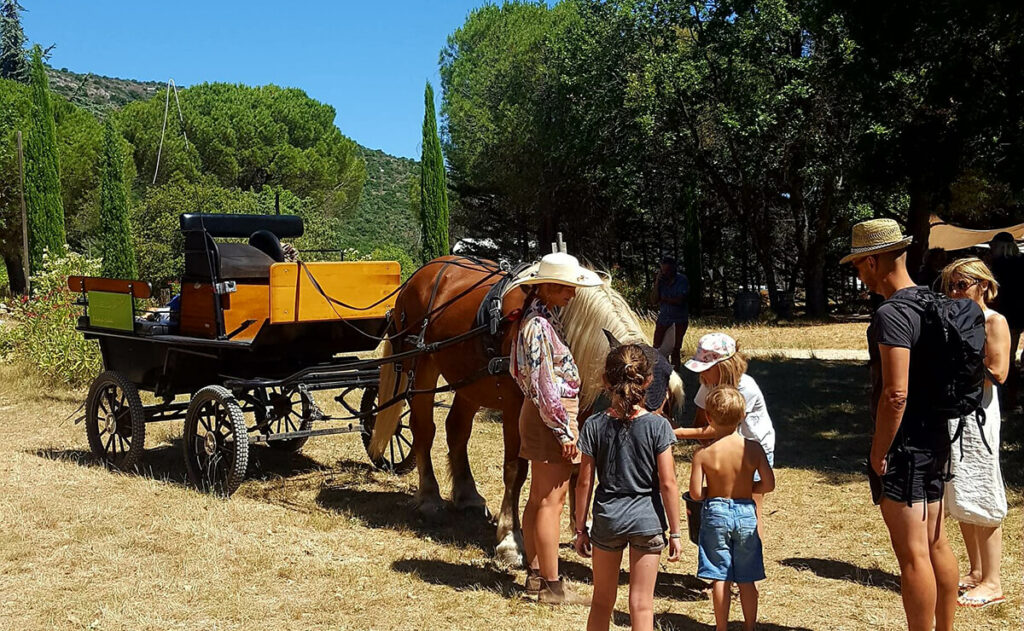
[85,371,145,470]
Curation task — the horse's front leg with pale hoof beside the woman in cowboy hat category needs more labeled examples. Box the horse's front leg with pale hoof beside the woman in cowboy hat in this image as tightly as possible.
[495,399,529,566]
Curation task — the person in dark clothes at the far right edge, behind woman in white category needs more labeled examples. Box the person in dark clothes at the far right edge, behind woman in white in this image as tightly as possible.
[989,233,1024,411]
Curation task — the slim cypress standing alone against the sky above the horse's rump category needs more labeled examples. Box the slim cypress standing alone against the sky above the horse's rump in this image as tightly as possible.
[420,81,450,260]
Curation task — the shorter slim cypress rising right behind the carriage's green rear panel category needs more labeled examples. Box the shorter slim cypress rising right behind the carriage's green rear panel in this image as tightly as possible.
[99,117,137,279]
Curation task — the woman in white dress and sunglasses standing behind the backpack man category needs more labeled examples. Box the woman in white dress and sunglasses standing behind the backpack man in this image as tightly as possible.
[942,258,1010,607]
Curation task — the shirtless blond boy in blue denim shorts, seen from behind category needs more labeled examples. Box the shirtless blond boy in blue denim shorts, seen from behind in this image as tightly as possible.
[690,386,775,631]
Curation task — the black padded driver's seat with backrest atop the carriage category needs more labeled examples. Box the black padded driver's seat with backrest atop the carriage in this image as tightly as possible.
[180,214,303,282]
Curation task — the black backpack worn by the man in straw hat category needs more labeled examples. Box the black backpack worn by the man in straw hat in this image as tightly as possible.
[893,289,992,453]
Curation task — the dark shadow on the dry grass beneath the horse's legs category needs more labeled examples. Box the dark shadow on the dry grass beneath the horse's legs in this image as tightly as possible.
[316,485,495,554]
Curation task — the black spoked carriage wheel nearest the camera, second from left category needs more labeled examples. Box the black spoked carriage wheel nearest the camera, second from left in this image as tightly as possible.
[184,385,249,496]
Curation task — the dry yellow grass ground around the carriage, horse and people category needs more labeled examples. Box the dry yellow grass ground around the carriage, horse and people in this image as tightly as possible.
[0,350,1024,631]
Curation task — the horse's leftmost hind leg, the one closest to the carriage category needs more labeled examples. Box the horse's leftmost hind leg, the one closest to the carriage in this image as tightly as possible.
[410,356,444,517]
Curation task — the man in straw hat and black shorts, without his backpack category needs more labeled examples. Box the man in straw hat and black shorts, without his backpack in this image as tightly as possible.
[840,219,958,631]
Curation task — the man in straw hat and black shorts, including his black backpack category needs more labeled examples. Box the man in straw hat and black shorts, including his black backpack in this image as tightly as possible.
[841,219,984,631]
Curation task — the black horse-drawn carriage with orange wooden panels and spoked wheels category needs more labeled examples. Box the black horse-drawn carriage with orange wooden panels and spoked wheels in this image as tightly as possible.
[68,214,428,494]
